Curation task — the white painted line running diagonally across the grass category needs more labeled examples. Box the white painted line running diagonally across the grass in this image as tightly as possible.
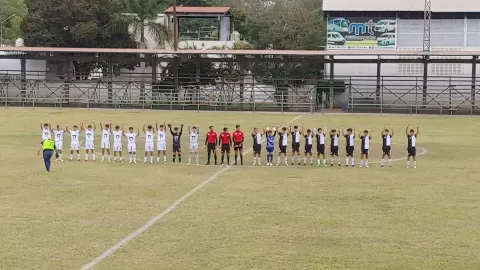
[81,115,303,270]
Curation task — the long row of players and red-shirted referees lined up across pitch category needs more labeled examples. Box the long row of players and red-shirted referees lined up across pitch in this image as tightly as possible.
[40,121,419,168]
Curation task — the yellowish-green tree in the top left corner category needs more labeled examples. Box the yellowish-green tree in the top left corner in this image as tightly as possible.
[0,0,27,45]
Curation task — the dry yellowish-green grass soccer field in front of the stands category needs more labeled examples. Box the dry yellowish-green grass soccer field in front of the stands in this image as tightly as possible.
[0,108,480,270]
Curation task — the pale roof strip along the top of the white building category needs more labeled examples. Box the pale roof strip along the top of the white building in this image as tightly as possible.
[323,0,480,12]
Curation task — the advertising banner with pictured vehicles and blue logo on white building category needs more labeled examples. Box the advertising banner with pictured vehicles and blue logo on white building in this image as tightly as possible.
[327,18,397,50]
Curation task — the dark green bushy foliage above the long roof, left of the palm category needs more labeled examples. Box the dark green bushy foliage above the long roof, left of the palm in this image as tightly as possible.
[21,0,136,48]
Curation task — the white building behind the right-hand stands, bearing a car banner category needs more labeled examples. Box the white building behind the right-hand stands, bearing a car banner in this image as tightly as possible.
[323,0,480,108]
